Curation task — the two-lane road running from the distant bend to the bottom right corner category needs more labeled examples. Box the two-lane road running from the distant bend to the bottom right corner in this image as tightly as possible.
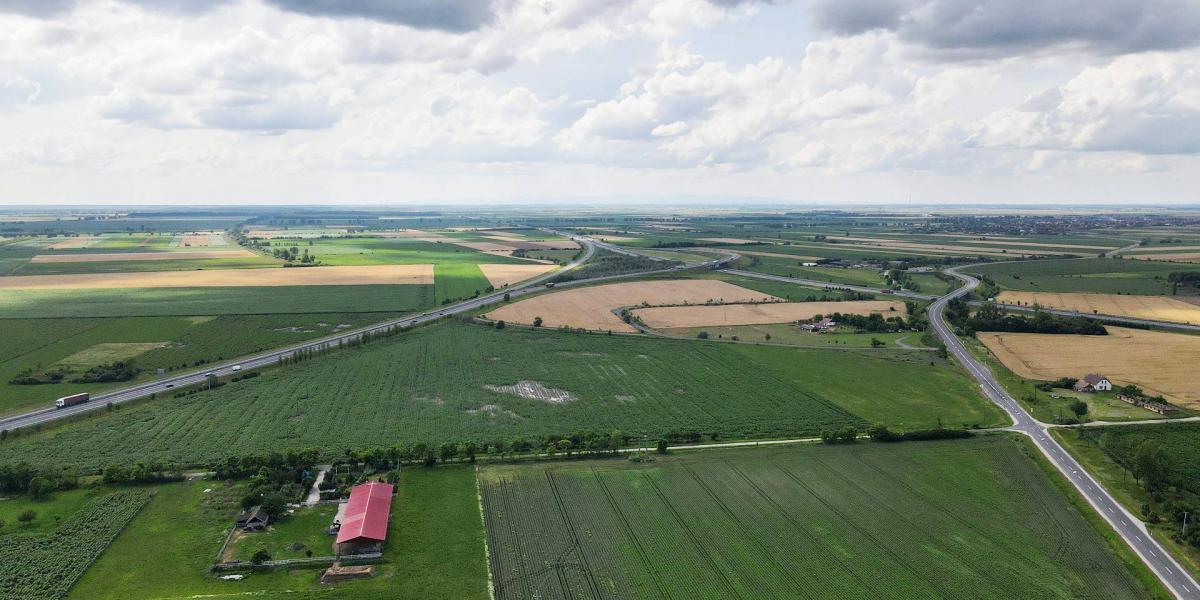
[929,269,1200,600]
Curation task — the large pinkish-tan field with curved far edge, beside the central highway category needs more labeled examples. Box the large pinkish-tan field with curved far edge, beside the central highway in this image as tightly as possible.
[486,280,779,332]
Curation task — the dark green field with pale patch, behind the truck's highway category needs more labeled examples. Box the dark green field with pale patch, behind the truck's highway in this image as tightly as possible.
[0,313,408,414]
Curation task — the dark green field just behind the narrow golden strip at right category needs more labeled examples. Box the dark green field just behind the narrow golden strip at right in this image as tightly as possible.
[967,258,1188,295]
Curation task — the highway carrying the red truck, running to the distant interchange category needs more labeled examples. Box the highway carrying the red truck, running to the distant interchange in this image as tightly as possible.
[0,232,738,430]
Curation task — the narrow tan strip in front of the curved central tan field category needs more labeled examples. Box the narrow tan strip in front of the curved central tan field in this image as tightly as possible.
[634,300,908,329]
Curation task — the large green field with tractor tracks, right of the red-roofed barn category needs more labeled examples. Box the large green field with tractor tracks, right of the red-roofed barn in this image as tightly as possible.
[480,436,1157,600]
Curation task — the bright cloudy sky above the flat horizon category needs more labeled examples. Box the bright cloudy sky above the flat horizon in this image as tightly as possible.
[0,0,1200,205]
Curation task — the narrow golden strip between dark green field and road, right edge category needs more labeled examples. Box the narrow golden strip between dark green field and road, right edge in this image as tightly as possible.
[997,292,1200,323]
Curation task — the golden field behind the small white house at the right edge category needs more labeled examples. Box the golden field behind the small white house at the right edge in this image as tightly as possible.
[976,326,1200,408]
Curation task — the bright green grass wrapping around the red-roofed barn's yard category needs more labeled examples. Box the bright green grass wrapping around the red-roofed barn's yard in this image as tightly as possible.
[70,467,487,600]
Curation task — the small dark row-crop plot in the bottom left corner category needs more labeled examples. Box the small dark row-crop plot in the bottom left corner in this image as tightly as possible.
[0,490,151,600]
